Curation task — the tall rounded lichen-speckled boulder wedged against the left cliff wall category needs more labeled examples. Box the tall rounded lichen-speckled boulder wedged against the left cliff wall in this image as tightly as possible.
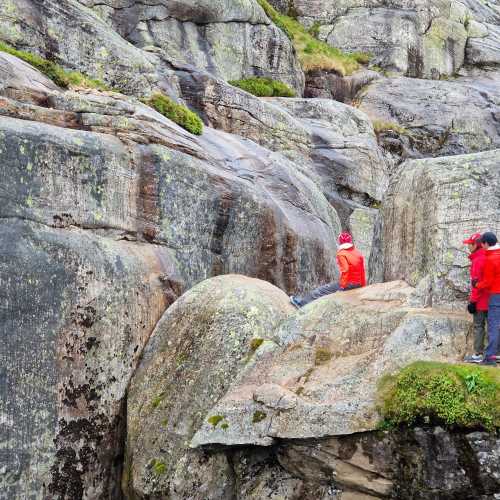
[124,275,293,500]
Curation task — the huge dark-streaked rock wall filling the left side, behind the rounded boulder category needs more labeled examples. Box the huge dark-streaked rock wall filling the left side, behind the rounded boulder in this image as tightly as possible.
[0,52,340,499]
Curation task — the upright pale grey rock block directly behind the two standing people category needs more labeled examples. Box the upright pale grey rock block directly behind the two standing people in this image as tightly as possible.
[382,150,500,307]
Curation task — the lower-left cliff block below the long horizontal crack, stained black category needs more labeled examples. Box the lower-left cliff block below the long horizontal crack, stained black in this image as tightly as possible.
[0,219,183,499]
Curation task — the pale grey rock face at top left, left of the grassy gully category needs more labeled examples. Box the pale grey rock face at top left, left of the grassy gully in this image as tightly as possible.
[0,0,304,95]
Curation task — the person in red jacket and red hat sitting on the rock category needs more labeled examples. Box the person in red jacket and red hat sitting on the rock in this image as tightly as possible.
[290,233,366,308]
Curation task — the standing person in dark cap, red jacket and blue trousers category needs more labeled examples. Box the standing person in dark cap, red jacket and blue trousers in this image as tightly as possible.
[476,232,500,366]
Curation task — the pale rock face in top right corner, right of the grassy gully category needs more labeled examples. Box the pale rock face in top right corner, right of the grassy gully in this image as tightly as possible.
[272,0,500,79]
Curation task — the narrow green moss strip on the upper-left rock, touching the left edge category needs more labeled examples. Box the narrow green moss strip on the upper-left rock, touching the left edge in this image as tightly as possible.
[0,42,110,90]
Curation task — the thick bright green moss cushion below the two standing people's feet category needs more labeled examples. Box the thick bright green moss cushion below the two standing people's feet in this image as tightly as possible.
[379,362,500,431]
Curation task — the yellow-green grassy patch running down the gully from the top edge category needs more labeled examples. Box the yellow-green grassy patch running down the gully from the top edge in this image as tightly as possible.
[257,0,371,76]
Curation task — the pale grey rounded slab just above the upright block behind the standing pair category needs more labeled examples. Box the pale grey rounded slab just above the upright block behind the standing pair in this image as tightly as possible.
[360,74,500,156]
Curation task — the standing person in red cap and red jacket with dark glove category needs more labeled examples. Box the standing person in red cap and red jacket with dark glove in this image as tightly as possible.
[464,233,490,363]
